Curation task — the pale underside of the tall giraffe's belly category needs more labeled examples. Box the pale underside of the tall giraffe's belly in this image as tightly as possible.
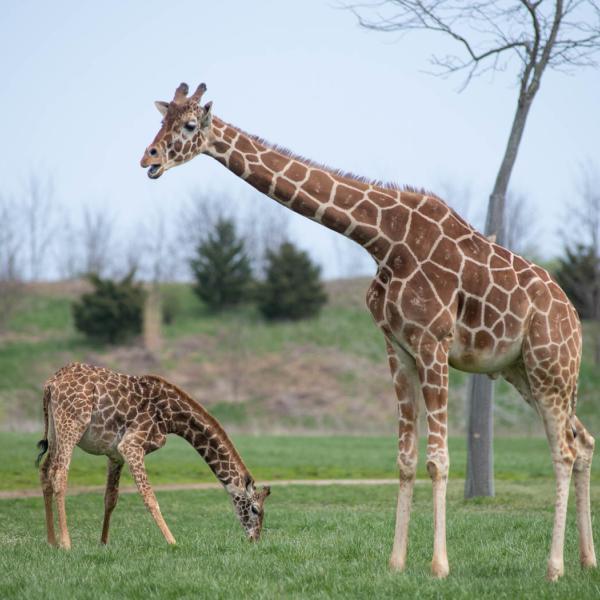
[448,336,523,374]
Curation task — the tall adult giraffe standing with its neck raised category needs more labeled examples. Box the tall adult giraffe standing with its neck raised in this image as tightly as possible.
[141,83,596,580]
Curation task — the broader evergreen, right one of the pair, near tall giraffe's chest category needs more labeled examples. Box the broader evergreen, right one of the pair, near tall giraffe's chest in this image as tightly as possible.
[258,242,327,320]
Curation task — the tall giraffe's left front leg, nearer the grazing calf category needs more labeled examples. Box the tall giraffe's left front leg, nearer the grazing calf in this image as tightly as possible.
[387,342,420,571]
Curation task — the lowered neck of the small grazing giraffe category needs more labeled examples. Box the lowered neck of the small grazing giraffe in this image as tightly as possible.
[162,381,251,491]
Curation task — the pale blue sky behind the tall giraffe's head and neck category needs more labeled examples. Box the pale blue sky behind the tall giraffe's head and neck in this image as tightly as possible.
[0,0,600,277]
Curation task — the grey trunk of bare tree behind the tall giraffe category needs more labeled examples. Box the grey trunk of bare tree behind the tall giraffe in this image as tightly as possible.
[465,93,531,498]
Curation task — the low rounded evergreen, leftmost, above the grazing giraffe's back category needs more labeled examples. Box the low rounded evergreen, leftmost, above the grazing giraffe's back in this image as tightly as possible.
[72,272,145,344]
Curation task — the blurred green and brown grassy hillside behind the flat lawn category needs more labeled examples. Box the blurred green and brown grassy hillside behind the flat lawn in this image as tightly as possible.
[0,279,600,435]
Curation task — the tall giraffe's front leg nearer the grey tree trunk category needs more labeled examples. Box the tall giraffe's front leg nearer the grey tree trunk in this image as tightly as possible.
[417,344,450,578]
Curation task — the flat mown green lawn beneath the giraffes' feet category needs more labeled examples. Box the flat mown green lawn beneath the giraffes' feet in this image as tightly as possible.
[0,434,600,599]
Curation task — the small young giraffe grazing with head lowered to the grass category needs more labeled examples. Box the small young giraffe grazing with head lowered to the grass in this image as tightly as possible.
[38,363,270,549]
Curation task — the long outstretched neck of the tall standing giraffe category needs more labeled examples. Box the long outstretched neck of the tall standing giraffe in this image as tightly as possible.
[206,117,403,260]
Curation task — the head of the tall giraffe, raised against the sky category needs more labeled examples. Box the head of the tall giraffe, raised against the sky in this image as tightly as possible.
[140,83,212,179]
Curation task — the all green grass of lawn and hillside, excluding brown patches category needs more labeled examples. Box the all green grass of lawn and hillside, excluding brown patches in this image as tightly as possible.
[0,282,600,600]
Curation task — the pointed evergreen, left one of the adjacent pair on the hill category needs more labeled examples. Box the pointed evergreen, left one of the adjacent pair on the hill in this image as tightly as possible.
[190,218,252,310]
